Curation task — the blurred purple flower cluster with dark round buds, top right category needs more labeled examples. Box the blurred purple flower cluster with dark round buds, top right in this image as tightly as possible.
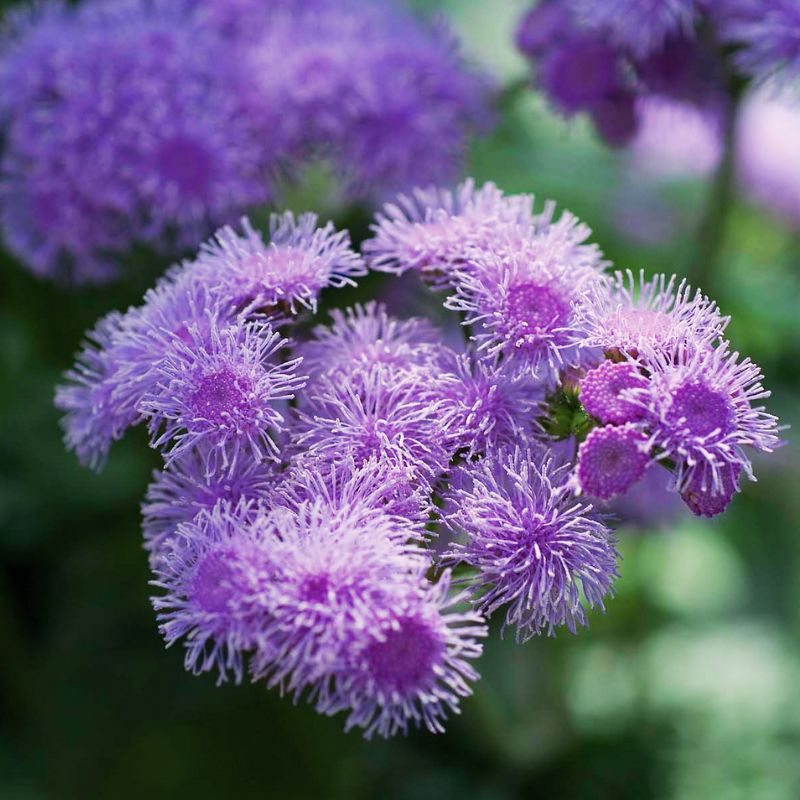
[516,0,800,146]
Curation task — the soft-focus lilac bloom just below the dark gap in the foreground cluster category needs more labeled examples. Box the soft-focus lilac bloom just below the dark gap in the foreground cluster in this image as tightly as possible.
[298,301,446,379]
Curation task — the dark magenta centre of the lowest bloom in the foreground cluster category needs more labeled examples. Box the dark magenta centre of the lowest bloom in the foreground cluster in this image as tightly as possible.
[366,617,444,694]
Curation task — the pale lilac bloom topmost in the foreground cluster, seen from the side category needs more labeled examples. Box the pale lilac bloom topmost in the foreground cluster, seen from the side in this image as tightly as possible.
[362,179,536,285]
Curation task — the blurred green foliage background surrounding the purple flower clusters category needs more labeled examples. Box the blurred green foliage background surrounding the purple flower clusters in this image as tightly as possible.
[0,0,800,800]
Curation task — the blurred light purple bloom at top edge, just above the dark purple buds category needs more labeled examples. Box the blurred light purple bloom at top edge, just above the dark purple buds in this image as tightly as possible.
[566,0,702,57]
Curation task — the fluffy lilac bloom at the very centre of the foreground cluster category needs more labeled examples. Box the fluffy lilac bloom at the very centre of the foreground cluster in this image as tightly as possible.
[296,365,450,478]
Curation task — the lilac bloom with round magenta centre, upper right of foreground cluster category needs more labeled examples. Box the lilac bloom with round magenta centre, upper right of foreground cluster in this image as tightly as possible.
[445,220,603,378]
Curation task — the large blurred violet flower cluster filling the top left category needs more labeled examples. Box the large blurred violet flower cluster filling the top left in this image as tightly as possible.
[0,0,487,283]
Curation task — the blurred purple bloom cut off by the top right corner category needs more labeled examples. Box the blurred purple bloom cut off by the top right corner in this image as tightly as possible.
[709,0,800,80]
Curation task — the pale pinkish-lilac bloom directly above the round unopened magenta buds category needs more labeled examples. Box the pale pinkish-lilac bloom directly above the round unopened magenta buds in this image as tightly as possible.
[575,271,729,356]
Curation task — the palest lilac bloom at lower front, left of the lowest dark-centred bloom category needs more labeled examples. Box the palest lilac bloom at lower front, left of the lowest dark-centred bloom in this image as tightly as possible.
[251,500,428,696]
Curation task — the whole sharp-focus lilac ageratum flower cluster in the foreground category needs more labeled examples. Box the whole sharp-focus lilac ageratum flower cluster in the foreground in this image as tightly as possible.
[56,181,779,736]
